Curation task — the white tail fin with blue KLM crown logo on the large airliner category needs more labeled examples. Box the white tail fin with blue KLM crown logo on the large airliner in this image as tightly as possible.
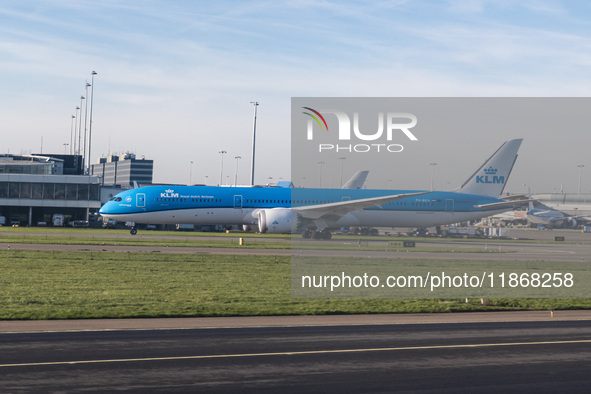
[458,138,523,197]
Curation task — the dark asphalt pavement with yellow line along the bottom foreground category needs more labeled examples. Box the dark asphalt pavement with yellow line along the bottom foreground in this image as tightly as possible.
[0,313,591,393]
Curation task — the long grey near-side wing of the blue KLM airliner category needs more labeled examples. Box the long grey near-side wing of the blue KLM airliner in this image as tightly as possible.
[292,191,431,225]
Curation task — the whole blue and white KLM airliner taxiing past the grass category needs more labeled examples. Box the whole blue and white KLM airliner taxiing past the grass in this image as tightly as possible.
[99,139,529,239]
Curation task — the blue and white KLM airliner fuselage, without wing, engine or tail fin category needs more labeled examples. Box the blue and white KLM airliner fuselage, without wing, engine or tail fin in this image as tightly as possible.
[100,186,507,227]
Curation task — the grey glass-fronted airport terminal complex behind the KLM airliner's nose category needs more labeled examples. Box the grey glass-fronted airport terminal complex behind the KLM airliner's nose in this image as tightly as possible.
[0,155,152,226]
